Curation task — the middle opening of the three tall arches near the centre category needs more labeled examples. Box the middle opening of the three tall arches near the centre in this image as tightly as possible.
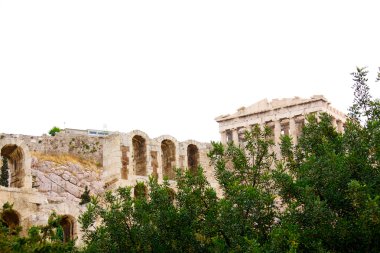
[161,140,176,180]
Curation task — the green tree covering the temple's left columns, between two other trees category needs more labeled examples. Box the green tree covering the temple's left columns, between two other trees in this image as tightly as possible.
[209,125,277,252]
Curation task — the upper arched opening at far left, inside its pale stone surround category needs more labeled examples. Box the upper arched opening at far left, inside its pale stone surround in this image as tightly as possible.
[0,144,25,188]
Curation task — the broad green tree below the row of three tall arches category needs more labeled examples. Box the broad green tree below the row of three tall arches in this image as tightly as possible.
[79,169,217,252]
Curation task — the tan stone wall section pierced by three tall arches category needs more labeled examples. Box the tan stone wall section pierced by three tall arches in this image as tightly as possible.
[113,130,215,188]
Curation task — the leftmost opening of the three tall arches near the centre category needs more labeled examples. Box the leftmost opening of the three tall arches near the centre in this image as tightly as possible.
[132,135,146,176]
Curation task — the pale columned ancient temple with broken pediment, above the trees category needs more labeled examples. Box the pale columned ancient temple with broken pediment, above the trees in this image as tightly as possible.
[215,95,346,149]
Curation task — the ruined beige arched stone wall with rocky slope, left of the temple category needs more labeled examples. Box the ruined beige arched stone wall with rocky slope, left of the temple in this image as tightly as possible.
[0,129,217,242]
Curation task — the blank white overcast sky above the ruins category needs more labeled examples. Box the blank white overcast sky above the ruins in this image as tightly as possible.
[0,0,380,141]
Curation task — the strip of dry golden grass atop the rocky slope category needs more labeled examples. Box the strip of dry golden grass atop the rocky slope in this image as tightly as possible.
[31,152,99,172]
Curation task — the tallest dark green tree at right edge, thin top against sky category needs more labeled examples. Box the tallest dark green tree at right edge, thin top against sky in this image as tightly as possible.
[270,68,380,252]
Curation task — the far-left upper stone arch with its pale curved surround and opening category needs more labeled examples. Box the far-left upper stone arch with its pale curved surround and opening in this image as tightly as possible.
[0,138,32,188]
